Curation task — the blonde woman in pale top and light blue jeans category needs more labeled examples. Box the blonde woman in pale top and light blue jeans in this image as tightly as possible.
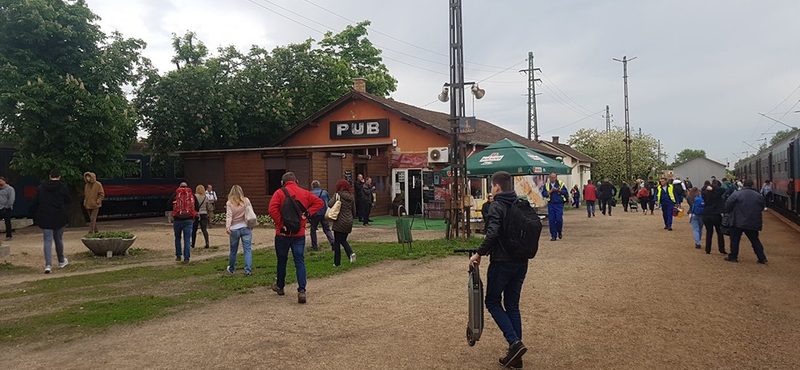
[225,185,253,275]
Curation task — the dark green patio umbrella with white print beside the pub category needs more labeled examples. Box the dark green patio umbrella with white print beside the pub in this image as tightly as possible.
[441,139,572,176]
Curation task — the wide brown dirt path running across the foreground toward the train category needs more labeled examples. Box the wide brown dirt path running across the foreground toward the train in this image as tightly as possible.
[0,207,800,369]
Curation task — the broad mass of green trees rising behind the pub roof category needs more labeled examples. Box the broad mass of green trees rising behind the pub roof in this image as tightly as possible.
[135,22,397,156]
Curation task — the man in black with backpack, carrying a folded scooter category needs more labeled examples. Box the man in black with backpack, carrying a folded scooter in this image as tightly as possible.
[469,171,542,369]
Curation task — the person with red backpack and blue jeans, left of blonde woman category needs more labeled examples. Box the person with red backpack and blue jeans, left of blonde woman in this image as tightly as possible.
[169,182,200,263]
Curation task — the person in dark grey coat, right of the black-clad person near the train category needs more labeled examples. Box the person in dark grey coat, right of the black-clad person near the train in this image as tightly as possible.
[725,179,767,264]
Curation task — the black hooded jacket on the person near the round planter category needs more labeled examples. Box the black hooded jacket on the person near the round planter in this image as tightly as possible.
[30,180,71,230]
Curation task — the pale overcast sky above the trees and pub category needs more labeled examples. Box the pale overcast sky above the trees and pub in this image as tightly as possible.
[87,0,800,165]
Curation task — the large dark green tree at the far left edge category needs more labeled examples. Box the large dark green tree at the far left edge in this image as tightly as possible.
[0,0,148,224]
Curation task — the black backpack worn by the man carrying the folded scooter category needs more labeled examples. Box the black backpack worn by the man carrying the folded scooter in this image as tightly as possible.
[501,200,542,260]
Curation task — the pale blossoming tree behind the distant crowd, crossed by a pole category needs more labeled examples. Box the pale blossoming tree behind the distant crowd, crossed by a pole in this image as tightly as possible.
[569,127,665,184]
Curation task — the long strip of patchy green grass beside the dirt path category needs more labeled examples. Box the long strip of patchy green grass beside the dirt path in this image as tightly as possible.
[0,239,480,343]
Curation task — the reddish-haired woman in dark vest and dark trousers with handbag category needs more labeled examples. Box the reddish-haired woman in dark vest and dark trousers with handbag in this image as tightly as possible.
[325,179,356,267]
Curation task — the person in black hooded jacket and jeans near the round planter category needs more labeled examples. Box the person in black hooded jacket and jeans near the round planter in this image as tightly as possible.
[30,169,72,274]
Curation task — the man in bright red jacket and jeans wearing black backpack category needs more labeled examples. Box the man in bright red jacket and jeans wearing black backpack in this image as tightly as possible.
[269,172,323,303]
